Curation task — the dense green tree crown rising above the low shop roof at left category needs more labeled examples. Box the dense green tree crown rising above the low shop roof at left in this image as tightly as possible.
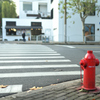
[2,0,17,18]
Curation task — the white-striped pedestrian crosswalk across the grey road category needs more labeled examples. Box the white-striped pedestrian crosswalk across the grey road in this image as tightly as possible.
[0,44,80,93]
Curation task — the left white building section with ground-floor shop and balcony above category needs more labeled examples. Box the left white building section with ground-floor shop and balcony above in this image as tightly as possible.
[2,0,52,41]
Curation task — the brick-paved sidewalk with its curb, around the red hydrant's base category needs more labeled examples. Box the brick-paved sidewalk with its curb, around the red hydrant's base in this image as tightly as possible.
[0,75,100,100]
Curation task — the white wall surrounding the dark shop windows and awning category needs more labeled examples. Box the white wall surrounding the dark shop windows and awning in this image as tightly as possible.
[2,18,52,41]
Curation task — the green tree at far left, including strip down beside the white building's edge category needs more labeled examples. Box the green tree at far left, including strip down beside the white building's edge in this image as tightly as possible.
[0,0,17,35]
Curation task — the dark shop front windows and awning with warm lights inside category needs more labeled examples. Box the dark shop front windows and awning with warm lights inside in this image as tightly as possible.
[5,22,43,41]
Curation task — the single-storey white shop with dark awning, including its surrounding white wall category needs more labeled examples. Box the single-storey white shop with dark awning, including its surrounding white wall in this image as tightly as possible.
[2,18,52,41]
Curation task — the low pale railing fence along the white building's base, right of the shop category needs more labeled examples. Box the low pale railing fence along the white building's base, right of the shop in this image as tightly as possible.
[33,35,100,43]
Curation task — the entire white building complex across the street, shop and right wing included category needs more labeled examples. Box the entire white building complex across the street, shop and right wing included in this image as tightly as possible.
[2,0,100,42]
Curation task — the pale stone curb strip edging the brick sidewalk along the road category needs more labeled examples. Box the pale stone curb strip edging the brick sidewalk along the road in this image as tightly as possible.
[0,79,80,100]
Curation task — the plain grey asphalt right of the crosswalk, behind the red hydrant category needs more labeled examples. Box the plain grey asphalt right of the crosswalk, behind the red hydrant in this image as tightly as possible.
[49,45,100,74]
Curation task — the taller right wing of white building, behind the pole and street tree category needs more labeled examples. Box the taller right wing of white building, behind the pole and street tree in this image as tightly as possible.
[51,0,100,42]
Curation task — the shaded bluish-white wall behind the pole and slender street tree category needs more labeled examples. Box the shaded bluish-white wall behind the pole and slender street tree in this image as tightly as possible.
[58,0,100,42]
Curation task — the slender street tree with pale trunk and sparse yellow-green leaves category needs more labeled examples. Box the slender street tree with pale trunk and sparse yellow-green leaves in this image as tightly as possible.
[58,0,100,42]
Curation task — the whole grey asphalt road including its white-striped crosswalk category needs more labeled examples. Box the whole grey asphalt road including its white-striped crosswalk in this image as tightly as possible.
[0,44,100,96]
